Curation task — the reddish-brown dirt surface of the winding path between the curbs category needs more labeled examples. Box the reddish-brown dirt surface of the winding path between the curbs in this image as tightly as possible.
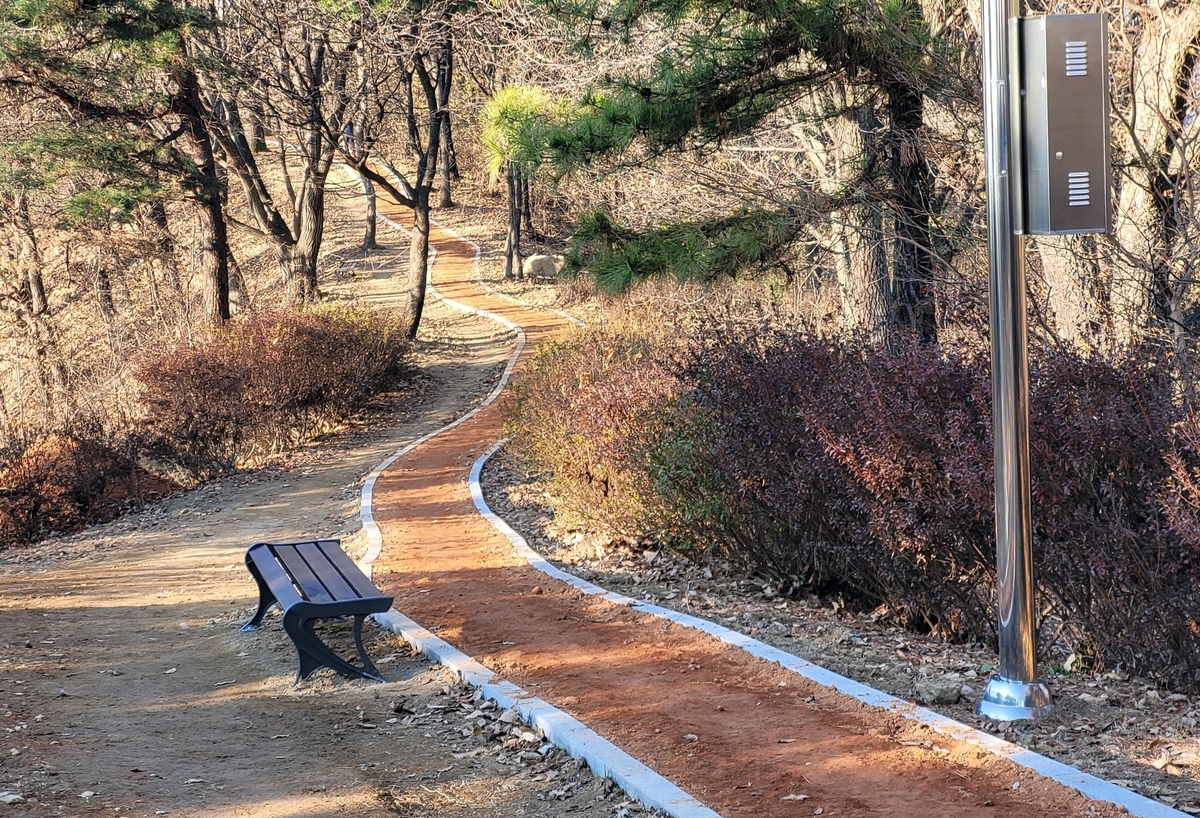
[374,208,1116,818]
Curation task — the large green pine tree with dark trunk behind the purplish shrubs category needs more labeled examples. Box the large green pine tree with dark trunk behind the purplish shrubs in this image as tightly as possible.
[547,0,943,341]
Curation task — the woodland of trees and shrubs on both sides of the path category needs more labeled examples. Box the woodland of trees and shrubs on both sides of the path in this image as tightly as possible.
[0,0,1200,690]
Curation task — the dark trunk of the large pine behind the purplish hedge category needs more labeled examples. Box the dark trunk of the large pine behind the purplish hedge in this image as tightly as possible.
[884,80,937,343]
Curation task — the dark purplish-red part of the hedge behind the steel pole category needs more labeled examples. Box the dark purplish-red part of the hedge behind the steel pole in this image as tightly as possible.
[667,337,1200,686]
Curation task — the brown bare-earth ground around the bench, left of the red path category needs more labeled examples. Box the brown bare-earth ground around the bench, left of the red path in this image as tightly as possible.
[0,216,638,818]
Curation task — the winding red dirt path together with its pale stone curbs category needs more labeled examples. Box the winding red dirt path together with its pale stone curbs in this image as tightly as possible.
[362,207,1183,818]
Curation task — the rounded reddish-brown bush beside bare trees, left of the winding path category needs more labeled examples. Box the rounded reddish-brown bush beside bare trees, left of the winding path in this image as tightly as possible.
[136,307,409,476]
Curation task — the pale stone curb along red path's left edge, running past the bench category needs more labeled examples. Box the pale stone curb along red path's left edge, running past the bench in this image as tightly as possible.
[359,216,721,818]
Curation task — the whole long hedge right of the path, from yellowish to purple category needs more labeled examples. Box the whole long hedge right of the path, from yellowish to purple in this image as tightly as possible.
[509,305,1200,690]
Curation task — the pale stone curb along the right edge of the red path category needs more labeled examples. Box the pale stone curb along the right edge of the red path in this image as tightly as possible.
[470,441,1187,818]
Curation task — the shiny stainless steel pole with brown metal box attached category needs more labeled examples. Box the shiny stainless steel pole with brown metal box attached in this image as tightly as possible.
[977,0,1112,721]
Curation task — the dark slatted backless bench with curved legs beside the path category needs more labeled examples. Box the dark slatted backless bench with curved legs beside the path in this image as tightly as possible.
[241,540,392,681]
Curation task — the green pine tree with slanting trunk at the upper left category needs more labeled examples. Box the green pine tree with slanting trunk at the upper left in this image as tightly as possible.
[0,0,229,321]
